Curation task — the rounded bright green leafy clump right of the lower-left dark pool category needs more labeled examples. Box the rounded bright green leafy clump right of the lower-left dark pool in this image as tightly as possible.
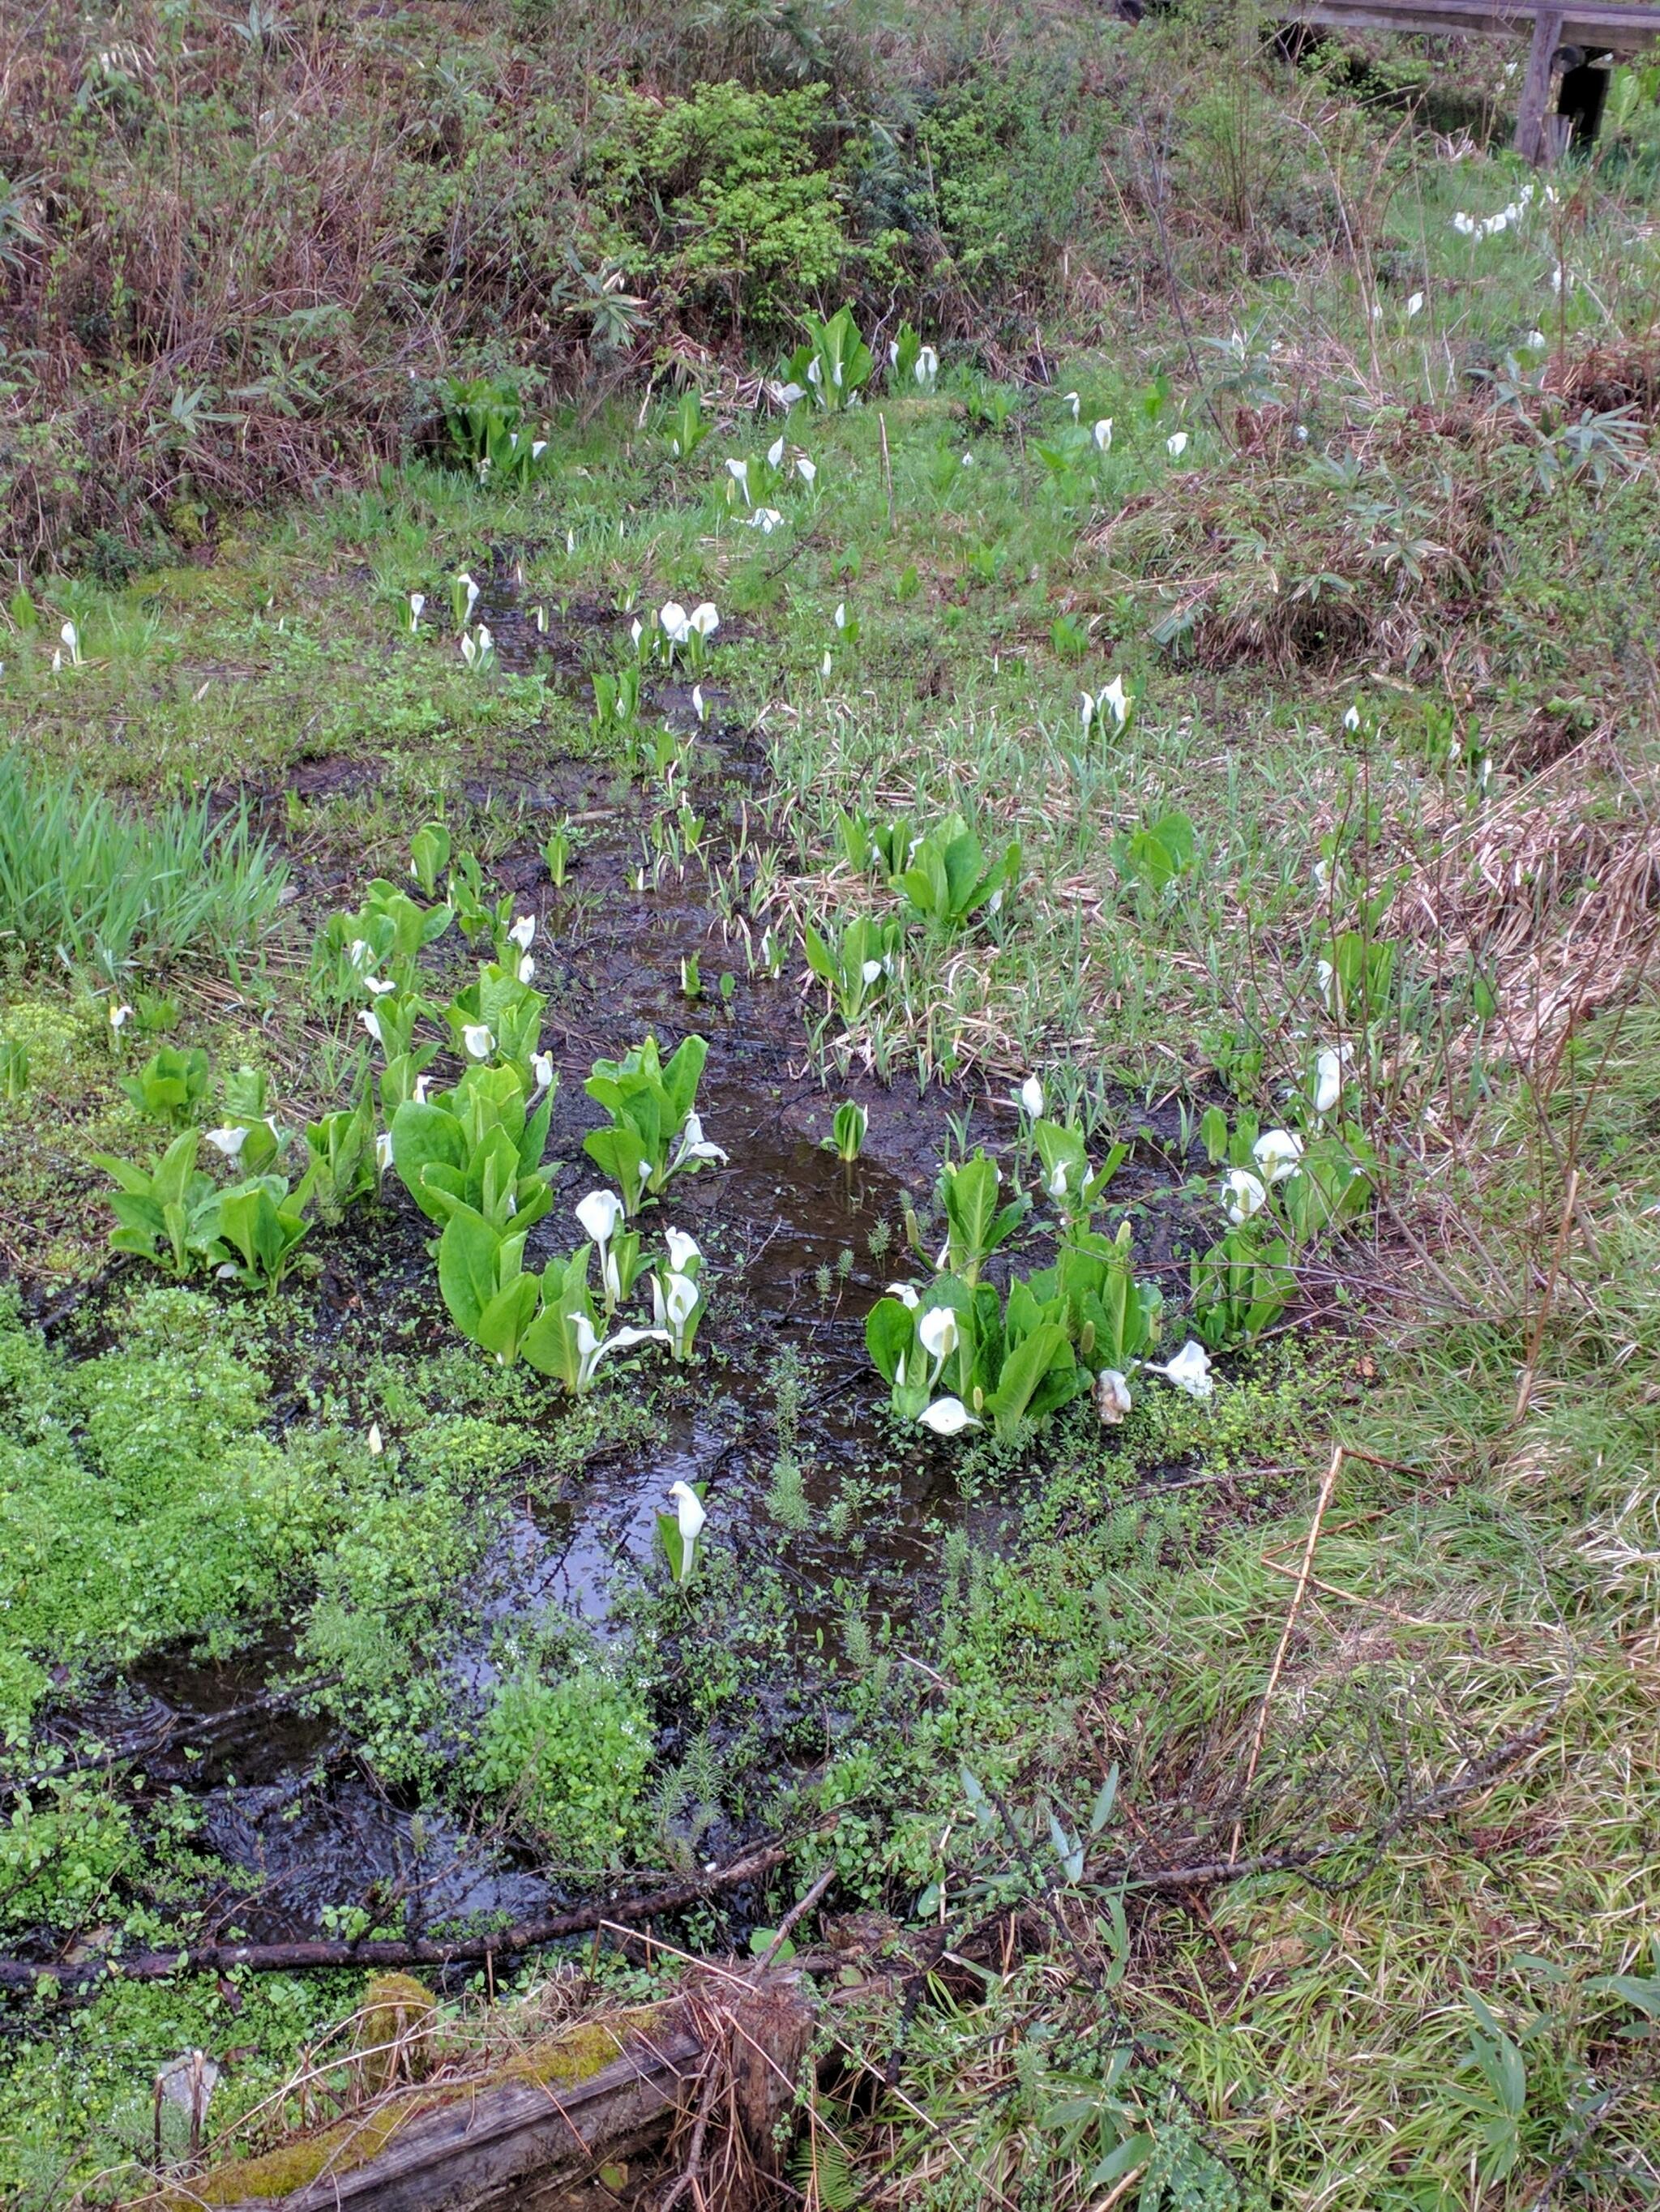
[473,1668,651,1867]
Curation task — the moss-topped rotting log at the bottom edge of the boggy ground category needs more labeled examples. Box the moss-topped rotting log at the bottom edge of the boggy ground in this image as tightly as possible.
[152,1966,812,2212]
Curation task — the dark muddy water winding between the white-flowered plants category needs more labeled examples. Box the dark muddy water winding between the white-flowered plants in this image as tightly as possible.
[45,582,1195,1940]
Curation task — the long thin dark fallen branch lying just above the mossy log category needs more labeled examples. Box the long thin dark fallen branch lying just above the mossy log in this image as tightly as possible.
[0,1842,794,1991]
